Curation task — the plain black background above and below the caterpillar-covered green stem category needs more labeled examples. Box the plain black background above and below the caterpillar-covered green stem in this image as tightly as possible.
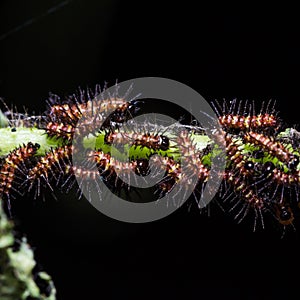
[0,0,300,300]
